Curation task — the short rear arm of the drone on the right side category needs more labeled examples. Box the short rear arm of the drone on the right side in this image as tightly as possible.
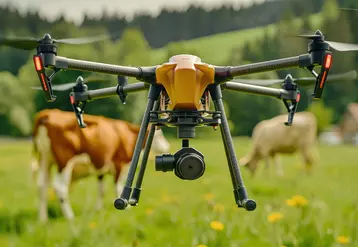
[222,81,290,99]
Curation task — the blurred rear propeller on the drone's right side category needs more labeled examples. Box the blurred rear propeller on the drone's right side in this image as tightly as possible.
[232,70,357,86]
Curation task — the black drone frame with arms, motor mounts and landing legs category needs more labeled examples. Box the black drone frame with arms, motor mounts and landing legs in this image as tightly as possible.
[25,30,332,211]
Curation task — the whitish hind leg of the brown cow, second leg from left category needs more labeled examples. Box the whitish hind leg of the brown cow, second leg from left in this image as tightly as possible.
[54,155,90,220]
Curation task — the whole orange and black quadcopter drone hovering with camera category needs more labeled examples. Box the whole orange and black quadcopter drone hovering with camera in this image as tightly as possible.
[0,30,358,211]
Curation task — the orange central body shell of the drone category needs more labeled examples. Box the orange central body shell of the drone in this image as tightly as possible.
[156,54,215,110]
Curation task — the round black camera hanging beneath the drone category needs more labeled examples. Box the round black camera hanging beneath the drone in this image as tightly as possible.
[155,147,205,180]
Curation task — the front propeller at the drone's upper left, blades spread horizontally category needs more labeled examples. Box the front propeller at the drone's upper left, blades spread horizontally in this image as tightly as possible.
[0,33,111,50]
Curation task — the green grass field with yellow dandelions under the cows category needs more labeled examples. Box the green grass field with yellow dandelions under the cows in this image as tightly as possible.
[0,138,358,247]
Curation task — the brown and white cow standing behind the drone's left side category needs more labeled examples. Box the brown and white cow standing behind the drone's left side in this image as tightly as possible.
[32,109,170,221]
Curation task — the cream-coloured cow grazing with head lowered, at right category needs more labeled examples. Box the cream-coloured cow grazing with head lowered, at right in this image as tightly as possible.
[239,112,318,176]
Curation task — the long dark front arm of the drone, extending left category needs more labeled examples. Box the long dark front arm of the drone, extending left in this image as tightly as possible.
[54,56,156,82]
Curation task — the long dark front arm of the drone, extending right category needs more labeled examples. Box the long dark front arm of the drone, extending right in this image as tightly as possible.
[215,54,311,83]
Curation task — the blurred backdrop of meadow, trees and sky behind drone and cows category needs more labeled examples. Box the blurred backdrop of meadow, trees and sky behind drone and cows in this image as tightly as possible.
[0,0,358,247]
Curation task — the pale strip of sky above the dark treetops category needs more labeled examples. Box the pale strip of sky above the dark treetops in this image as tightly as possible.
[0,0,265,24]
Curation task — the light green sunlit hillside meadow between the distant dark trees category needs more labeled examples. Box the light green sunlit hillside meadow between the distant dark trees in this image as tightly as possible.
[152,13,322,65]
